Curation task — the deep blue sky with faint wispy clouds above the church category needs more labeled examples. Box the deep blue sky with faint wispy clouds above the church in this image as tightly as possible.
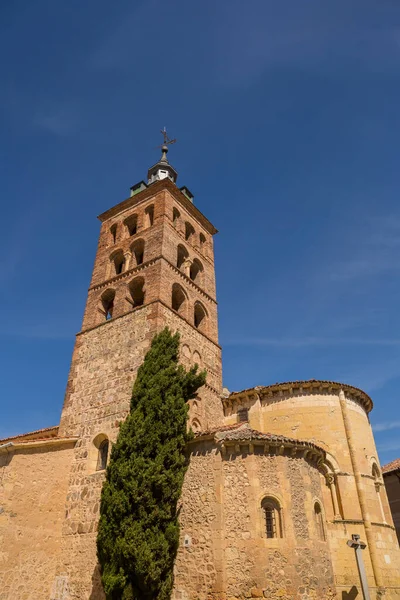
[0,0,400,463]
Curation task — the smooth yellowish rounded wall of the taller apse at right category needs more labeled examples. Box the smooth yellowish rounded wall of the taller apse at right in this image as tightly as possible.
[226,381,400,599]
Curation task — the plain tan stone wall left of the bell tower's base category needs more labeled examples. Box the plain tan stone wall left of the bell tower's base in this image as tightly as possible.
[0,441,73,600]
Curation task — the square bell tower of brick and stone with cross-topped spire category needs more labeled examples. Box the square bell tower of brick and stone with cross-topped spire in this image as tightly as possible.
[58,132,223,600]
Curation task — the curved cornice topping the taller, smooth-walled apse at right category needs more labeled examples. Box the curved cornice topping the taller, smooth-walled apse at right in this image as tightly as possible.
[227,379,373,413]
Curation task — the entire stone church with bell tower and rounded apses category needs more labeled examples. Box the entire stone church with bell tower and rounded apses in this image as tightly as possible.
[0,142,400,600]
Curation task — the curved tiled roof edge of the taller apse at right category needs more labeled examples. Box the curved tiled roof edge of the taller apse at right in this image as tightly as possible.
[227,379,373,412]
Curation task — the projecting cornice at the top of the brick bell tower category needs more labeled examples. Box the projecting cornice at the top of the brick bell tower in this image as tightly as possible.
[98,178,218,235]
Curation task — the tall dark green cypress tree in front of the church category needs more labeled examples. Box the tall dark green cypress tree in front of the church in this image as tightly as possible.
[97,328,205,600]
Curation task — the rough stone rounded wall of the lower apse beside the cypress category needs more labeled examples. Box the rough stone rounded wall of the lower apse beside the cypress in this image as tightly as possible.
[173,442,335,600]
